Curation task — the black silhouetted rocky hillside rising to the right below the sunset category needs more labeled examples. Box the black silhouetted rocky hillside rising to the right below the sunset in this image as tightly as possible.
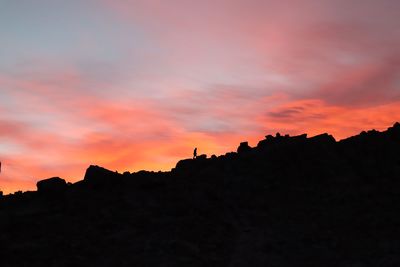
[0,124,400,267]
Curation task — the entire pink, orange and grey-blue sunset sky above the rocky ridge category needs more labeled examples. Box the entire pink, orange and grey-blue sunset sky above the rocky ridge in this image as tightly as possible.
[0,0,400,193]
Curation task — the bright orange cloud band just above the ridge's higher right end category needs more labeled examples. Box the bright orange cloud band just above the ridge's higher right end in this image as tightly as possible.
[259,99,400,139]
